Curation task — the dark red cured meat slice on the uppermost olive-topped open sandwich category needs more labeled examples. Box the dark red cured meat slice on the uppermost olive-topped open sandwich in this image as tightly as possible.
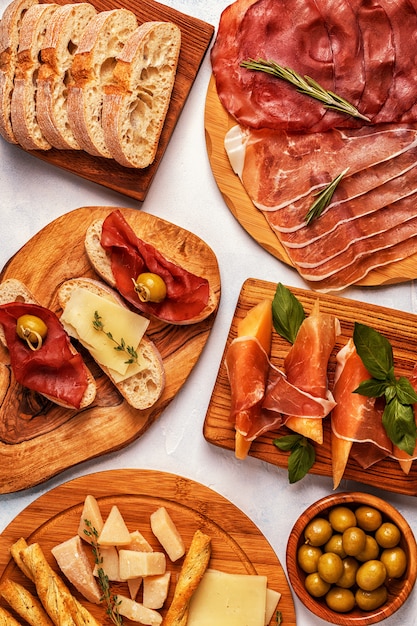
[101,210,210,323]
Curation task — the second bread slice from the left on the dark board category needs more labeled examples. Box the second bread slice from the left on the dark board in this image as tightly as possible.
[11,4,58,150]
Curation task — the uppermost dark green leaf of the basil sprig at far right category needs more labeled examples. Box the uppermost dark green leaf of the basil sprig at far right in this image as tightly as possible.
[353,322,394,380]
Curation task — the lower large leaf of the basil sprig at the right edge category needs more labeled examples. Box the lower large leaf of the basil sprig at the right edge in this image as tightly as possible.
[382,398,417,456]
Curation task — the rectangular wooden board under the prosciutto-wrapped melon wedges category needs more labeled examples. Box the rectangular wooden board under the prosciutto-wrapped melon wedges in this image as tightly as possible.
[203,278,417,496]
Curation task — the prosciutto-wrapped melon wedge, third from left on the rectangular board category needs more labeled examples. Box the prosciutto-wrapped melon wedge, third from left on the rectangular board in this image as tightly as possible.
[331,339,392,489]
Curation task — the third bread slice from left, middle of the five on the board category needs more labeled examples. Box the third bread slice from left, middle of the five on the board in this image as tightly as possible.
[36,2,97,150]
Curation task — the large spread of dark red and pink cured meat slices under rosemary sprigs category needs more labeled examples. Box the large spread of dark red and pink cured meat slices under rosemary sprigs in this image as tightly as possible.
[212,0,417,291]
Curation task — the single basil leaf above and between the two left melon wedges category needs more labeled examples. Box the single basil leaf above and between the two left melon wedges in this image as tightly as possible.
[272,283,305,343]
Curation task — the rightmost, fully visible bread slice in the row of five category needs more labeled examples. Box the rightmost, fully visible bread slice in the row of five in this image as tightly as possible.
[102,22,181,168]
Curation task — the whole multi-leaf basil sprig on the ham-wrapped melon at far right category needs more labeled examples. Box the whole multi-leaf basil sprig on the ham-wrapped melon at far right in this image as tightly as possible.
[353,322,417,455]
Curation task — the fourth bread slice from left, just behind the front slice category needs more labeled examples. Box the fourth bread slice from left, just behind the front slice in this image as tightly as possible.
[67,9,137,158]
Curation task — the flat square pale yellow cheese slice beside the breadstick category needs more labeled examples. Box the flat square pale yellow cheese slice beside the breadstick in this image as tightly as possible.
[187,569,267,626]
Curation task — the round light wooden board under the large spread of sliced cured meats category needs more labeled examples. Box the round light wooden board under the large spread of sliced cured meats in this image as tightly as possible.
[204,76,417,286]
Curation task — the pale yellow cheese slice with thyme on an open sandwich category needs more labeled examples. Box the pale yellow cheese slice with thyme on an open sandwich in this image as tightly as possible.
[60,287,149,382]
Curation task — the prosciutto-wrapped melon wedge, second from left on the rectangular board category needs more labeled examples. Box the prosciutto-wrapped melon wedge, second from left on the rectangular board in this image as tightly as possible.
[284,300,340,444]
